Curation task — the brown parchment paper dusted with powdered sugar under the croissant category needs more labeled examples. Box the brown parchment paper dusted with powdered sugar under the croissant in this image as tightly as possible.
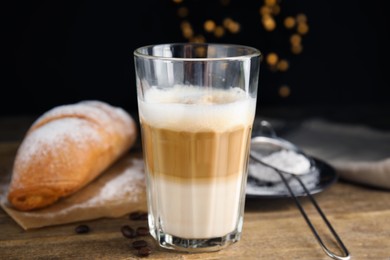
[0,155,146,230]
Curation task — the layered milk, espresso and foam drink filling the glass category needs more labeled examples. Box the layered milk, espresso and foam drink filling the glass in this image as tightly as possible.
[138,86,256,242]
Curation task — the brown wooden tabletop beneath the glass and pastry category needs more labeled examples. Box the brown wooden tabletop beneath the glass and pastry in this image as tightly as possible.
[0,118,390,260]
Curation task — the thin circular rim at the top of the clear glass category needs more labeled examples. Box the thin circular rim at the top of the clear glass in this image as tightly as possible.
[133,42,262,61]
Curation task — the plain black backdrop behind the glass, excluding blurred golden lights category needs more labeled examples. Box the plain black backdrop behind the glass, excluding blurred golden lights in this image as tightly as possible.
[0,0,390,122]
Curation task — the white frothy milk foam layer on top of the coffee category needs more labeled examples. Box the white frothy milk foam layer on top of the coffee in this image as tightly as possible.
[138,86,256,132]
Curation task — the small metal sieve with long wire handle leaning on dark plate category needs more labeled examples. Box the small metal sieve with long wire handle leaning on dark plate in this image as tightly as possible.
[250,121,350,260]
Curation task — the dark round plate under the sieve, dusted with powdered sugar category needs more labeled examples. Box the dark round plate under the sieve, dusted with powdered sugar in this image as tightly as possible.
[246,158,338,198]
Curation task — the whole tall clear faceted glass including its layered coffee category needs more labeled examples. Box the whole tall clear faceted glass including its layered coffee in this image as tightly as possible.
[134,43,260,252]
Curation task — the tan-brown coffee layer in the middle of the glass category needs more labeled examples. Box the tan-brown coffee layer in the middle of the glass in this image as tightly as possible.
[141,122,251,181]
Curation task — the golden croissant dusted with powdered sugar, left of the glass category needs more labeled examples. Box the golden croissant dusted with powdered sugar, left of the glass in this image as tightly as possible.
[8,100,137,211]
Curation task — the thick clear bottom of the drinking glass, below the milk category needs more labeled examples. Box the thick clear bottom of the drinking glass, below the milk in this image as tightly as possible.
[152,231,241,253]
